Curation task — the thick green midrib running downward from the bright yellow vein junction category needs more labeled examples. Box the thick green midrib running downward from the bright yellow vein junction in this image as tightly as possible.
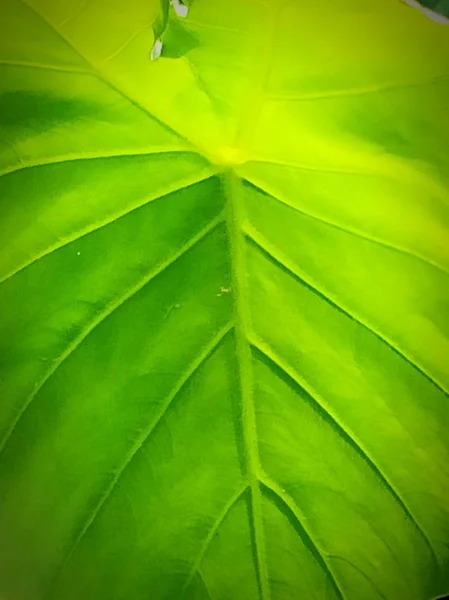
[222,169,270,600]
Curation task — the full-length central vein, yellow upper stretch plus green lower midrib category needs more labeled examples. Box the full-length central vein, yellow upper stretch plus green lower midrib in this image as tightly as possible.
[213,0,286,600]
